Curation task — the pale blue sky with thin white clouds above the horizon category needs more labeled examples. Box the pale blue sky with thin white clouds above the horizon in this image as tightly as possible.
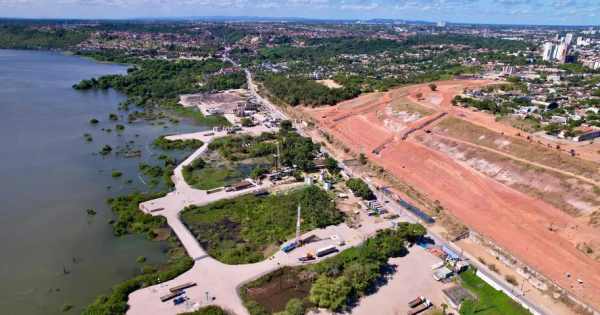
[0,0,600,25]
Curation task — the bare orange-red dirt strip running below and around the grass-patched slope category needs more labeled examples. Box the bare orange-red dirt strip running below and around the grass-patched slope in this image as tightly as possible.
[304,80,600,308]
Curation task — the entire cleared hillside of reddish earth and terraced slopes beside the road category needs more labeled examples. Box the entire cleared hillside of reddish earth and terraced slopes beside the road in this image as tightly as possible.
[299,80,600,309]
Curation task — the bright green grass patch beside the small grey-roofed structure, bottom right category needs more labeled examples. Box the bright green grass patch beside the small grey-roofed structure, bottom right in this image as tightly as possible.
[460,271,531,315]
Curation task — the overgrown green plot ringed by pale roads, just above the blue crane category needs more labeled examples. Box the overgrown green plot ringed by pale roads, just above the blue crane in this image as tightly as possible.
[181,186,344,265]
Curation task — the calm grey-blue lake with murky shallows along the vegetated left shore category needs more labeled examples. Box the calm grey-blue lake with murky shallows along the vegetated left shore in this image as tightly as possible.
[0,50,208,314]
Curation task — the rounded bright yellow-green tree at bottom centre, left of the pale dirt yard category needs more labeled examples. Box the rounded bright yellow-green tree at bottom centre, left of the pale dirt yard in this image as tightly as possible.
[310,276,352,311]
